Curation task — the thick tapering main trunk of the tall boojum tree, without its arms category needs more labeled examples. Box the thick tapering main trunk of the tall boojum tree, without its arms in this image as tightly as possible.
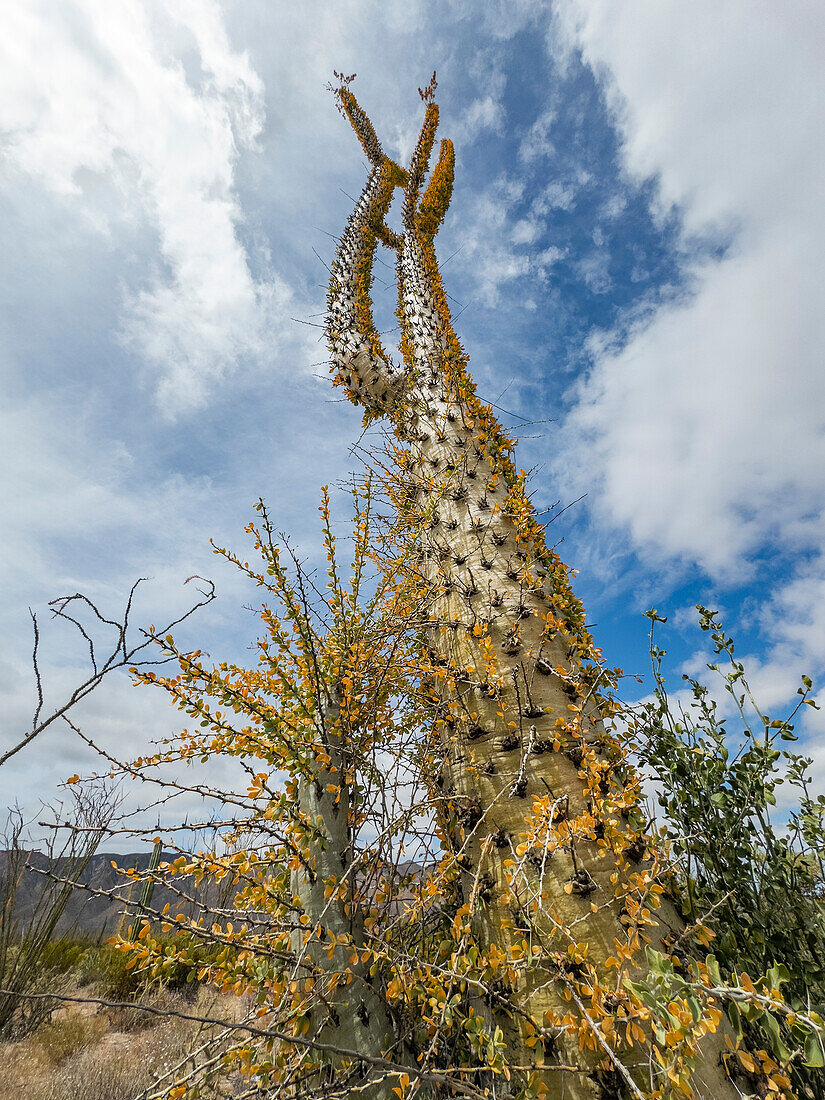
[398,233,738,1100]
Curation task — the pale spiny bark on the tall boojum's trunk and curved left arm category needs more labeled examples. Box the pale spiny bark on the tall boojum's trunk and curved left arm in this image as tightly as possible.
[328,94,738,1100]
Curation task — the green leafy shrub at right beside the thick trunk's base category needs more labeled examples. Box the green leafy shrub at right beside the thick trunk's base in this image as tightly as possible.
[630,606,825,1100]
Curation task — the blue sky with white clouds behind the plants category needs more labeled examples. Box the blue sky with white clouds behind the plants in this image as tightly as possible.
[0,0,825,846]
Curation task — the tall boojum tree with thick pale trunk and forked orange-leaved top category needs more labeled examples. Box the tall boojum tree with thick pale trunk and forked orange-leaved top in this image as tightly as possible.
[327,74,738,1100]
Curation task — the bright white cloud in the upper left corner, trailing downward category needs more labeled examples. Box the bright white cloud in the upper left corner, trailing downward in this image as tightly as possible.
[0,0,278,416]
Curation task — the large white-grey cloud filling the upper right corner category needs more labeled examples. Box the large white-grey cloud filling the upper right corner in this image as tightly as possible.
[557,0,825,580]
